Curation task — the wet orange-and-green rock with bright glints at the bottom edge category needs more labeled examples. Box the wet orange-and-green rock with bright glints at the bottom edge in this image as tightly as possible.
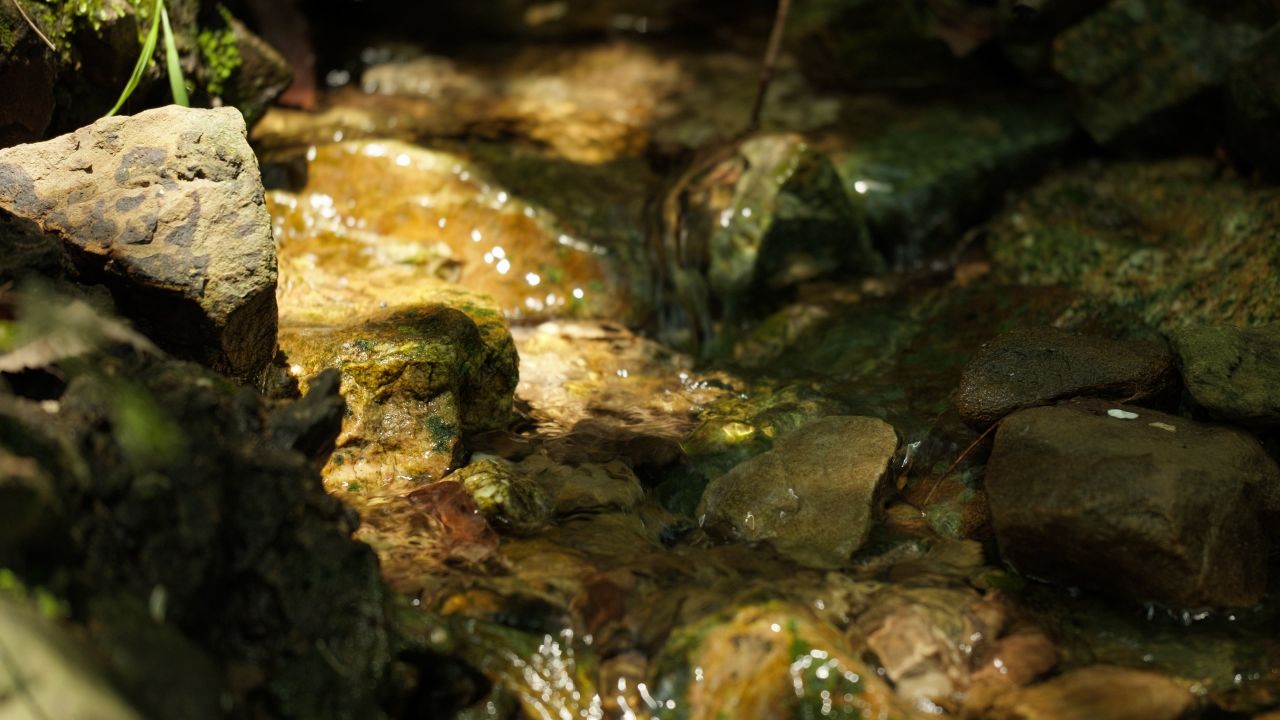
[653,603,923,720]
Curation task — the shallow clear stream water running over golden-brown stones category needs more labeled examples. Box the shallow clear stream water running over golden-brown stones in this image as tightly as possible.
[257,33,1280,719]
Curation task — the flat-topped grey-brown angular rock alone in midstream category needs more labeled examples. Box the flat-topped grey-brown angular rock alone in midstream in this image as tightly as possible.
[698,416,897,568]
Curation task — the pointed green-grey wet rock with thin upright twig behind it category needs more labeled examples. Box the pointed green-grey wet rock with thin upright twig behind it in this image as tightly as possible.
[662,135,883,342]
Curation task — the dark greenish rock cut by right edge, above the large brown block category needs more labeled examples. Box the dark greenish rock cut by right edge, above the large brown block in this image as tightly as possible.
[1172,325,1280,428]
